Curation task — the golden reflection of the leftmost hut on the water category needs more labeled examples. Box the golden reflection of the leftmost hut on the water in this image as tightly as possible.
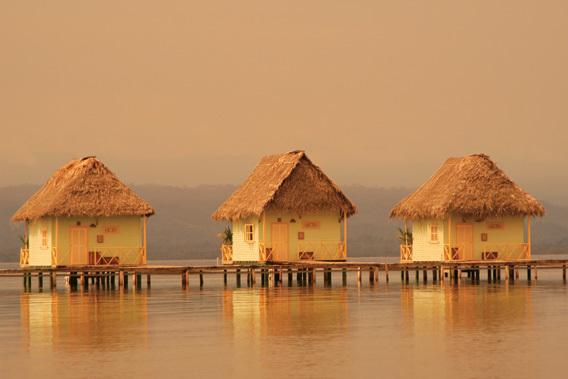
[20,291,147,354]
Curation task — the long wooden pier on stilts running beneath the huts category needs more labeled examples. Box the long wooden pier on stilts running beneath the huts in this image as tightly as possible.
[0,259,568,288]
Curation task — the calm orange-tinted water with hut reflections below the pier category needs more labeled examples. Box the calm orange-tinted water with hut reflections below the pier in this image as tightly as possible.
[0,259,568,378]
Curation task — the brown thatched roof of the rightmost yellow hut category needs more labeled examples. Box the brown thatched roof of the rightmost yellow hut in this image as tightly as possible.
[389,154,544,221]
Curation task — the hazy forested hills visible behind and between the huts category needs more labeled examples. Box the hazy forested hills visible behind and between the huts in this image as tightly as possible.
[0,185,568,262]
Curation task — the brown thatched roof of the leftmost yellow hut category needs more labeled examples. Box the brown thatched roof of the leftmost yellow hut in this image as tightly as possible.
[12,157,154,222]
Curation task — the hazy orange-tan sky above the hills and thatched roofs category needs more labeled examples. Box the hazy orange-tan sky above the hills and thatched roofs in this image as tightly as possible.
[0,0,568,203]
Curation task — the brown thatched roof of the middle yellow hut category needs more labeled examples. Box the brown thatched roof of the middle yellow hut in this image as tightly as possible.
[212,151,357,221]
